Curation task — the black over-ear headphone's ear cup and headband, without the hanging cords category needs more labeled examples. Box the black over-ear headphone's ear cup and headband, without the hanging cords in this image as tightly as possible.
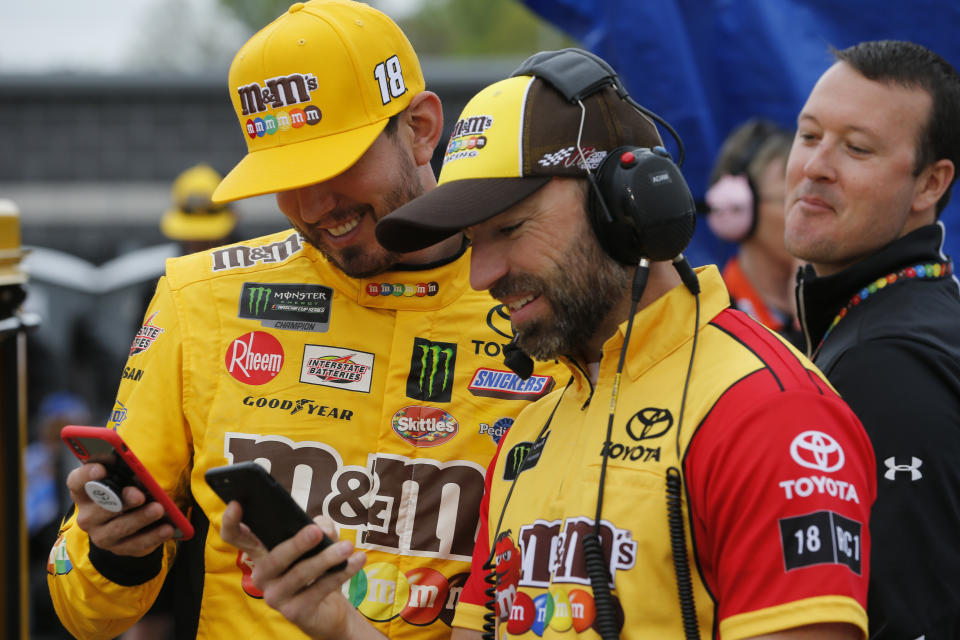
[512,48,696,265]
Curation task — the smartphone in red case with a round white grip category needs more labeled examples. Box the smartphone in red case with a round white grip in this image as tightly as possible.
[60,424,193,540]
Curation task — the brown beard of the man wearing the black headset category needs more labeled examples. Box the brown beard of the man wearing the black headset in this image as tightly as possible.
[490,230,632,360]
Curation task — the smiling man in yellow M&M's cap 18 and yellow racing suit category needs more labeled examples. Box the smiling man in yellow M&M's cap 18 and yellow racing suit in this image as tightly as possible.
[48,0,560,640]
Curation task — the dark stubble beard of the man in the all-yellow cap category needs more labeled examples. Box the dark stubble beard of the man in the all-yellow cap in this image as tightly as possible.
[293,146,425,278]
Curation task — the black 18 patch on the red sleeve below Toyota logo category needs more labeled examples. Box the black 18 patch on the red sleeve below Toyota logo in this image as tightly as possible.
[780,511,861,575]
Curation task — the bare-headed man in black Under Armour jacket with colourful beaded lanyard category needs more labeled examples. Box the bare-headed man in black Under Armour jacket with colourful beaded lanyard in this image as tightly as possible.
[786,40,960,640]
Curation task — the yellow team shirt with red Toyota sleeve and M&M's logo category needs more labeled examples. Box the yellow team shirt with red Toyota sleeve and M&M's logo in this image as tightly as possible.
[454,267,876,640]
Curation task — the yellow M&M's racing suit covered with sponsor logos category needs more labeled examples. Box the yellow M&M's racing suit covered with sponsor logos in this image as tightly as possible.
[48,230,560,640]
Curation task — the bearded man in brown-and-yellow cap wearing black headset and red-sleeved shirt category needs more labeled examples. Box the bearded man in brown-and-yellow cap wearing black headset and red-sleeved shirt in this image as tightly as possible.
[232,50,875,640]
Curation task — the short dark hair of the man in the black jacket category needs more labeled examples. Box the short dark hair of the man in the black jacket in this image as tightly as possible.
[831,40,960,217]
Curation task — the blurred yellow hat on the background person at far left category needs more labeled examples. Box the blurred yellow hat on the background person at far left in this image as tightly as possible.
[160,164,237,240]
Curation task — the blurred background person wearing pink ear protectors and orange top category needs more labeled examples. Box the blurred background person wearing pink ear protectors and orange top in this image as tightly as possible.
[705,118,802,346]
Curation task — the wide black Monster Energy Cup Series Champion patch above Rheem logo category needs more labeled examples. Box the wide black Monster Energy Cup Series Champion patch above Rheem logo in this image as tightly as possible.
[237,282,333,332]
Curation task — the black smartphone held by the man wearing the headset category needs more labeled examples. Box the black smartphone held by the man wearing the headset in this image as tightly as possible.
[204,462,347,573]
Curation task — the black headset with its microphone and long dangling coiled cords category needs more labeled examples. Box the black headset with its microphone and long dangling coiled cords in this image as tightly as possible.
[484,48,700,640]
